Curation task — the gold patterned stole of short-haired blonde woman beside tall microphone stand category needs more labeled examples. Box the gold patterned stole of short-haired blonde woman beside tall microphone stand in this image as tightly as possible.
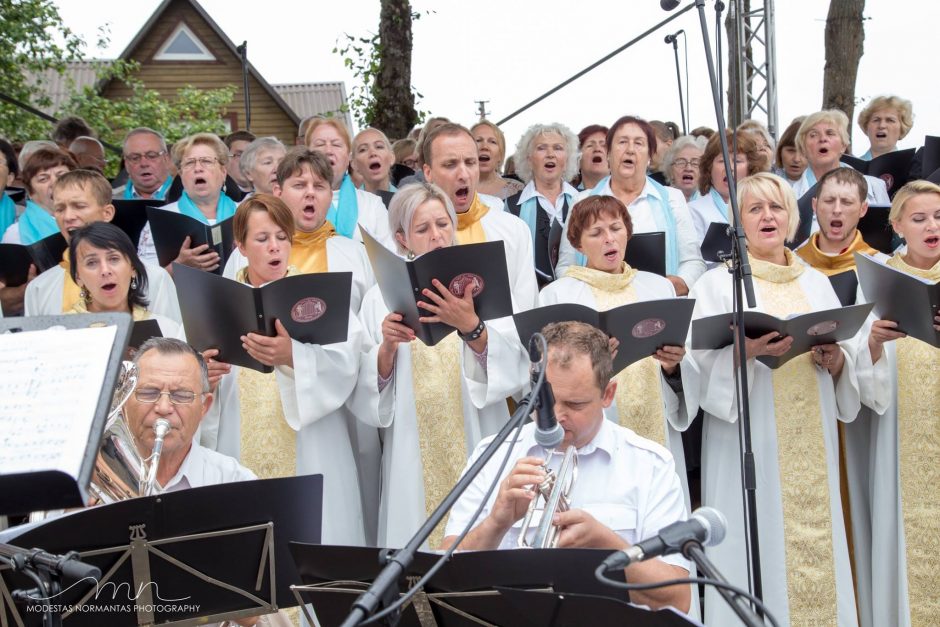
[751,249,837,625]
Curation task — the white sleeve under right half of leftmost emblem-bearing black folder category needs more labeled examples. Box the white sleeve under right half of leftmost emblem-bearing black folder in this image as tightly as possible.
[274,312,362,431]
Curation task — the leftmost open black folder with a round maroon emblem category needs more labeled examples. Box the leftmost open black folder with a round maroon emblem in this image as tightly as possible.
[173,263,352,372]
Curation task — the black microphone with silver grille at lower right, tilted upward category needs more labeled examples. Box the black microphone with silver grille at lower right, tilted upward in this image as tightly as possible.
[604,507,728,570]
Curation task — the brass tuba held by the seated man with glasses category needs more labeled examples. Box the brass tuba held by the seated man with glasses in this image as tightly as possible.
[89,361,170,503]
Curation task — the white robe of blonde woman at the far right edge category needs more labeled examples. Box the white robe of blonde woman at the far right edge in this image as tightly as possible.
[848,314,928,627]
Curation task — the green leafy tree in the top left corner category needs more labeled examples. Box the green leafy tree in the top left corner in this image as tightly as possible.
[0,0,84,141]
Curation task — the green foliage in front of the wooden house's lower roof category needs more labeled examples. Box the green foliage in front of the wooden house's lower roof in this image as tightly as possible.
[59,61,237,173]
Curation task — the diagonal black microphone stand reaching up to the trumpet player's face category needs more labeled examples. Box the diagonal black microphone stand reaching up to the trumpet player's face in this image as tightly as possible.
[342,378,547,627]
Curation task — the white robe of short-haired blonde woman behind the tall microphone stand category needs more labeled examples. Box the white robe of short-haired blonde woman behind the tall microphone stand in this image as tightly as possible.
[689,260,861,626]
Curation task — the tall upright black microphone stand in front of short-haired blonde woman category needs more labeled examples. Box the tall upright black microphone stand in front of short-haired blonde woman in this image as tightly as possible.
[695,0,763,600]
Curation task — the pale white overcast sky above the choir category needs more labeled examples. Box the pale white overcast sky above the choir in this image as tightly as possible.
[56,0,940,154]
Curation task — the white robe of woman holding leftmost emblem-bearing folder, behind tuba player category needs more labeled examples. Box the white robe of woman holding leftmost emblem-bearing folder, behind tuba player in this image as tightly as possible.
[200,313,365,546]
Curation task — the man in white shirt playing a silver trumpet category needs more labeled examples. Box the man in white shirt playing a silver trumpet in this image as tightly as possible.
[444,322,691,612]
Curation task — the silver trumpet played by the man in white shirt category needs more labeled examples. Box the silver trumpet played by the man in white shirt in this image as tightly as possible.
[517,446,578,549]
